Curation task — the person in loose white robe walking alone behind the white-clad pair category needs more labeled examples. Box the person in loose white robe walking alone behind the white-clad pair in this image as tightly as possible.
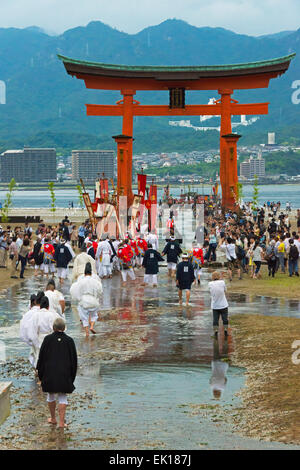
[70,263,102,338]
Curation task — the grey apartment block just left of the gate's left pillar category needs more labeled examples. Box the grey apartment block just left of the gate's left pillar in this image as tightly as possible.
[72,150,115,181]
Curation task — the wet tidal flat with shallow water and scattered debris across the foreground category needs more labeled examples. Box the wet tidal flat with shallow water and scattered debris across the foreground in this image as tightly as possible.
[0,269,299,449]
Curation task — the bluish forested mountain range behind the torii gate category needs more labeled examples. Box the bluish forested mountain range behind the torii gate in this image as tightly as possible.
[0,20,300,153]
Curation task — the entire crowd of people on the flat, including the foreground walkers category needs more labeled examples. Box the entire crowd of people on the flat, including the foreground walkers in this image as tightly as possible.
[15,201,300,427]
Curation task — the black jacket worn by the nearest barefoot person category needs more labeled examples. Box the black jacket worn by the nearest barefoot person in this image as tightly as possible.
[36,331,77,393]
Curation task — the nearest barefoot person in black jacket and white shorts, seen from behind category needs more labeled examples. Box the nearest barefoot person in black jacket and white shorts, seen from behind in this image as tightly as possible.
[37,318,77,428]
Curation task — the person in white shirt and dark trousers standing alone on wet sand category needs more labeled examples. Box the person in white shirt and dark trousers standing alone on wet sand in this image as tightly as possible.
[208,271,228,338]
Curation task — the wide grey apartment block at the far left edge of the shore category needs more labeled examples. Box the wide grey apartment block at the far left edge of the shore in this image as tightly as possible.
[0,147,57,183]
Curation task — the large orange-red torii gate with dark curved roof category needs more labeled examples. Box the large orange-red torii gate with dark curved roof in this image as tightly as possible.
[58,54,296,209]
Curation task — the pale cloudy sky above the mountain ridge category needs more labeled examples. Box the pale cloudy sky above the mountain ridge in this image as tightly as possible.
[0,0,300,36]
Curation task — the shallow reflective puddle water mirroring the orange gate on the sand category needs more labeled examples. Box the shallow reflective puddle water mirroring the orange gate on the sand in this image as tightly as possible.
[0,270,299,449]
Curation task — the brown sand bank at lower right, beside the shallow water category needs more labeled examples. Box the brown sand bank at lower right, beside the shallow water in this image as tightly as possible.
[227,315,300,444]
